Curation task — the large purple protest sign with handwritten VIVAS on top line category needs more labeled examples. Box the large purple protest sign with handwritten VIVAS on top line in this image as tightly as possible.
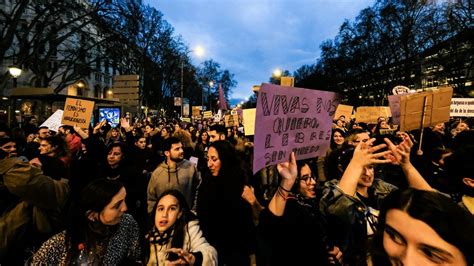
[253,84,339,173]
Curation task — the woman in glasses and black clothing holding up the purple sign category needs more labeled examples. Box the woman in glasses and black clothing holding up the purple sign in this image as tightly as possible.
[259,153,342,265]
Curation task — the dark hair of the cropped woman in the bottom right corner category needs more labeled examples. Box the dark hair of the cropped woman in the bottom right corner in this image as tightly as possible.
[370,189,474,265]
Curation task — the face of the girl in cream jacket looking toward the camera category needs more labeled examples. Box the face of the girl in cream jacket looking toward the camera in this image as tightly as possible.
[155,195,182,233]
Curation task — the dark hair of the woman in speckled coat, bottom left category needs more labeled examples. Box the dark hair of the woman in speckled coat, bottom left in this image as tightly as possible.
[65,178,124,257]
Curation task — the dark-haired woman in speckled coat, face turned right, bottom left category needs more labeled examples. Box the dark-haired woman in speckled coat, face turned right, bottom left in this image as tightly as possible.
[32,179,140,265]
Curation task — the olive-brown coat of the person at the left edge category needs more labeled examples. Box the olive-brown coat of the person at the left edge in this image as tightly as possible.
[0,158,69,264]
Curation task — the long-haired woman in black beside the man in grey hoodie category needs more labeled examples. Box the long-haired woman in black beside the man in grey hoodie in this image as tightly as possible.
[197,140,256,265]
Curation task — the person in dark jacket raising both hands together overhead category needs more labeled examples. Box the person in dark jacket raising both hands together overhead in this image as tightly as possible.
[321,134,432,265]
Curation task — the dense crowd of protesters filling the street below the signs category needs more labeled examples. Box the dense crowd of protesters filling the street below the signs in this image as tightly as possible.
[0,113,474,266]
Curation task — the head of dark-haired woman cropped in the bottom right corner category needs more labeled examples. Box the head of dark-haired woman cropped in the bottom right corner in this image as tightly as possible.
[369,189,474,265]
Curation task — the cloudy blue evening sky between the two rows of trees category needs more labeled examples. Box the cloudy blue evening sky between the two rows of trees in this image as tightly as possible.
[144,0,374,103]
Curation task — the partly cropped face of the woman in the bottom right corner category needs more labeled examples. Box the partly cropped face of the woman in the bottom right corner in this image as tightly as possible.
[383,209,467,265]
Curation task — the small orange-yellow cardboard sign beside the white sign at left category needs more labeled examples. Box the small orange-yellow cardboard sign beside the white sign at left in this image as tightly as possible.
[61,98,94,128]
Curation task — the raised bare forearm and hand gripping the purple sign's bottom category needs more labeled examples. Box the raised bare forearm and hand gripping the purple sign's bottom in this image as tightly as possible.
[268,152,298,216]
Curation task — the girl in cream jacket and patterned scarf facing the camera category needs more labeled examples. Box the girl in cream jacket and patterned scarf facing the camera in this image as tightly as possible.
[144,189,217,266]
